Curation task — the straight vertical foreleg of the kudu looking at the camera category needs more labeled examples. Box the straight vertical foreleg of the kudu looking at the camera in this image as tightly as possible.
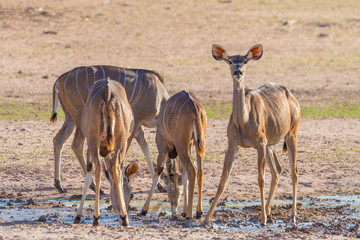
[257,143,267,225]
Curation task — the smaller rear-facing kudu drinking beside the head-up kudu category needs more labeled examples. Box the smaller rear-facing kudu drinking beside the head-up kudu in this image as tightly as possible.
[140,91,207,219]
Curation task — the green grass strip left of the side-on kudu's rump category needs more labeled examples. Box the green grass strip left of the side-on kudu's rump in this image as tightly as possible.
[0,101,64,120]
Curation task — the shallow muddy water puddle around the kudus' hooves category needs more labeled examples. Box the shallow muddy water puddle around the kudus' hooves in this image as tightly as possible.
[0,195,360,237]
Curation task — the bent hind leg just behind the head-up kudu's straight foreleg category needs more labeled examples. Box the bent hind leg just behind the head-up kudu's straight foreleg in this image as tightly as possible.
[265,146,282,217]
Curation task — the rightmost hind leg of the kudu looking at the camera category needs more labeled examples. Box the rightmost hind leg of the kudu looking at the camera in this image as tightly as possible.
[285,134,299,223]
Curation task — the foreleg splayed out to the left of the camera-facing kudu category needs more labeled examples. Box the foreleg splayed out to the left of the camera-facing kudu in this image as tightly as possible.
[202,140,239,225]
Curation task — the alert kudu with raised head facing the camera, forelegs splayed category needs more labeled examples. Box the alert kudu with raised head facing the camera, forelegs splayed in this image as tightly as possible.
[203,44,301,225]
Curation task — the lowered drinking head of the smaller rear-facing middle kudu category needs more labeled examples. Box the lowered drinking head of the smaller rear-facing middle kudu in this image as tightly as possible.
[163,158,184,214]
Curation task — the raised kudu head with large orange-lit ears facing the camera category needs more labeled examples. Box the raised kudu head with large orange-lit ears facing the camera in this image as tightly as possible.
[212,44,263,85]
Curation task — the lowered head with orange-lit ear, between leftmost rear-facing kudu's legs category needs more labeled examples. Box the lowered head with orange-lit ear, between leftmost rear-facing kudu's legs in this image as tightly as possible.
[103,159,139,212]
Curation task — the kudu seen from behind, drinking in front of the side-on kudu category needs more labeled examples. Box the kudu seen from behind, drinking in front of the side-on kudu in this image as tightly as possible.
[74,80,134,226]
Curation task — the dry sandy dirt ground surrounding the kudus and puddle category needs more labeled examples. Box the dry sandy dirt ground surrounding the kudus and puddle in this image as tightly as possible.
[0,0,360,239]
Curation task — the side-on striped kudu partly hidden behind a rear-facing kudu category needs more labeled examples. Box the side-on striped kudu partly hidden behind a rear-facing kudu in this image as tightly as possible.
[50,66,169,193]
